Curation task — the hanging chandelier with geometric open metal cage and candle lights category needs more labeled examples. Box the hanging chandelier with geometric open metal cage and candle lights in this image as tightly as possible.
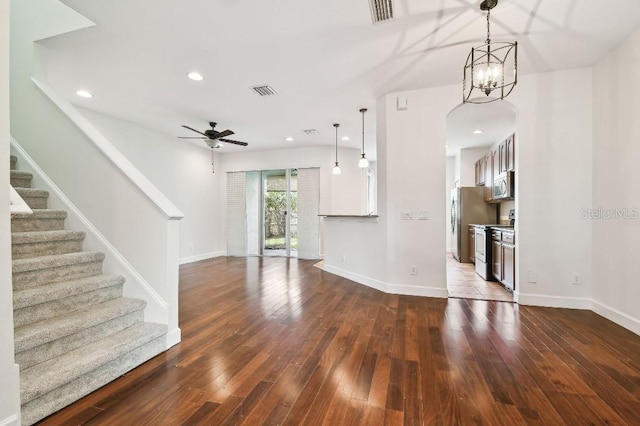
[462,0,518,104]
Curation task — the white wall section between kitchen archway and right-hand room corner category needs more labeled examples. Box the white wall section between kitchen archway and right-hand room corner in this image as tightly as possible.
[509,69,592,309]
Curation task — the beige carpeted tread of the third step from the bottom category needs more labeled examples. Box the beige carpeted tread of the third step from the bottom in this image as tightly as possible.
[13,274,124,310]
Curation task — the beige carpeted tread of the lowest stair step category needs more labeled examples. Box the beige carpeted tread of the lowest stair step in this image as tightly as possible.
[20,323,167,405]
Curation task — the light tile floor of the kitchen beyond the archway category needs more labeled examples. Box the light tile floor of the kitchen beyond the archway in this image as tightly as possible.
[447,253,513,302]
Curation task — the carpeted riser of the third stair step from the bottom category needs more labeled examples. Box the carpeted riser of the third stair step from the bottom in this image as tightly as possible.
[13,285,122,327]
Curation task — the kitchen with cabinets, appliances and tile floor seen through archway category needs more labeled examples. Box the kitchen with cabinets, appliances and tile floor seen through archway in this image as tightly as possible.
[447,134,516,302]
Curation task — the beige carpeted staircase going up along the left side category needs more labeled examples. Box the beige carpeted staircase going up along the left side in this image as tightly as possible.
[11,156,167,425]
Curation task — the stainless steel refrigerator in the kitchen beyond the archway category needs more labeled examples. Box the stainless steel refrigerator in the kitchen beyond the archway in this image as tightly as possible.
[451,186,497,263]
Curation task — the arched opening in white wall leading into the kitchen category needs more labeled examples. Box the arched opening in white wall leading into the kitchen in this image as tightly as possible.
[446,101,518,302]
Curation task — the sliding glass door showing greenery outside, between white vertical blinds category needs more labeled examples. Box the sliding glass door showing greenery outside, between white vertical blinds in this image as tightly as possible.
[261,169,298,257]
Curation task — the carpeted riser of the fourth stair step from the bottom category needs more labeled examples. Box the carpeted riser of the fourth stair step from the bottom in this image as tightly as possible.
[13,261,102,290]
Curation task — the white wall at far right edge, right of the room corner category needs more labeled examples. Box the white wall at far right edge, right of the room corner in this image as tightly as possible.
[584,25,640,334]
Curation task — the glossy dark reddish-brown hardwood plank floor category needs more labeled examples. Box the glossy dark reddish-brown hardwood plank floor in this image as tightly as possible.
[42,258,640,425]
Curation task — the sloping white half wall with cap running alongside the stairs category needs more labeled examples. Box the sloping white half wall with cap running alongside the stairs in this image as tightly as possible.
[11,80,183,348]
